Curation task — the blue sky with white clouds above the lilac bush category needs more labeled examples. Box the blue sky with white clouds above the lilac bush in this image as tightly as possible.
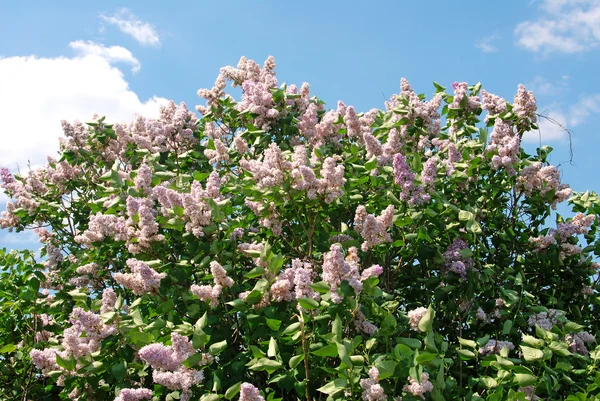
[0,0,600,248]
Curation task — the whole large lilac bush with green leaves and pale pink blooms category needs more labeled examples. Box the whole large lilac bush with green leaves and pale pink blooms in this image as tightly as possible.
[0,54,600,401]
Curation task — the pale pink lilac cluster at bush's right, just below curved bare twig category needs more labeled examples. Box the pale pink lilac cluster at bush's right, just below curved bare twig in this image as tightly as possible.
[517,162,573,209]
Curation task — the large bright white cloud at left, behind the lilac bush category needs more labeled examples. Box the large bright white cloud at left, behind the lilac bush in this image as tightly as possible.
[0,42,167,172]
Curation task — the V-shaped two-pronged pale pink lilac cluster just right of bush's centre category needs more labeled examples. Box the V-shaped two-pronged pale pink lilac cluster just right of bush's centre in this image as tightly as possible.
[354,205,395,251]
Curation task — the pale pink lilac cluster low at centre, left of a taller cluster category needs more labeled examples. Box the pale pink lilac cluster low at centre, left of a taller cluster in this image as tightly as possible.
[271,259,320,302]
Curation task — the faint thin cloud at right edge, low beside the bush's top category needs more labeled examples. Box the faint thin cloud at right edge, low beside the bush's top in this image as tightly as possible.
[523,94,600,142]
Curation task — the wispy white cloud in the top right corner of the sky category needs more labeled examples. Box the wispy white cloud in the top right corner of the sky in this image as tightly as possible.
[515,0,600,53]
